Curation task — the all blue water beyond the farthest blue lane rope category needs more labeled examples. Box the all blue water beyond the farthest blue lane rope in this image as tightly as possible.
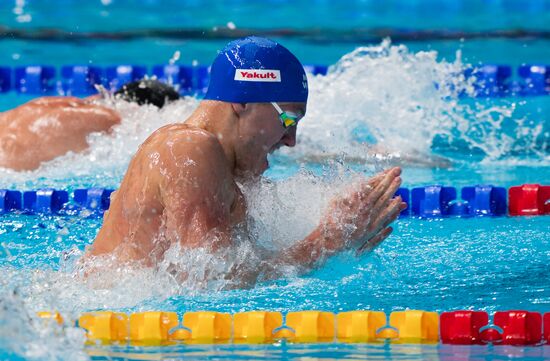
[0,0,550,65]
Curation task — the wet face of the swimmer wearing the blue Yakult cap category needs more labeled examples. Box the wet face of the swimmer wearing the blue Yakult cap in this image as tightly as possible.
[230,103,306,176]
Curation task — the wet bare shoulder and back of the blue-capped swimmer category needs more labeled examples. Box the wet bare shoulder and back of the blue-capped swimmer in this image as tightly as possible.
[90,124,242,264]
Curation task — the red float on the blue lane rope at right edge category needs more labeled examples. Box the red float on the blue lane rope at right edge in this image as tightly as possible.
[508,184,550,216]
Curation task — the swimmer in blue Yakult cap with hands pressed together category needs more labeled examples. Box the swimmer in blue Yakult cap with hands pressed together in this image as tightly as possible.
[85,37,406,283]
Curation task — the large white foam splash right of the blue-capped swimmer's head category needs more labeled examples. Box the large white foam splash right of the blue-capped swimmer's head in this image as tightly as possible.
[300,41,549,161]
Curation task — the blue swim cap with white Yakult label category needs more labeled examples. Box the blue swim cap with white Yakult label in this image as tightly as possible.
[204,36,308,103]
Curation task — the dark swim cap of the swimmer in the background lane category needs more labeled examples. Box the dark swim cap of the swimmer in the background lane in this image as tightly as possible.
[115,79,180,108]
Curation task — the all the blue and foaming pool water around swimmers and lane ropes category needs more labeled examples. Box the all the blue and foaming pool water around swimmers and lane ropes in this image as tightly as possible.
[0,0,550,360]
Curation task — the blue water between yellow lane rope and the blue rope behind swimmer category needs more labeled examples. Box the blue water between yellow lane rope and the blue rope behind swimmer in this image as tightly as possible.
[0,208,550,313]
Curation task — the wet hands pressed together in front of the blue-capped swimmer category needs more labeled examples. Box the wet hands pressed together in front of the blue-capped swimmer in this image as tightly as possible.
[280,167,407,269]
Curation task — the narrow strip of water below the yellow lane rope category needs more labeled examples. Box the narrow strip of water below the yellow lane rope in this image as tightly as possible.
[2,344,550,361]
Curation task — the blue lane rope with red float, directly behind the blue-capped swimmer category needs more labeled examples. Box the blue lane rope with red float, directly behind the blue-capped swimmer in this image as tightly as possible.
[0,184,550,218]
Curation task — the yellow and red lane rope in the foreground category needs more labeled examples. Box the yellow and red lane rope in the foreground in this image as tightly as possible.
[38,310,550,346]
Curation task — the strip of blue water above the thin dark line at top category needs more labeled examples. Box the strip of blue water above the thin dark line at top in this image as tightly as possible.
[0,0,550,31]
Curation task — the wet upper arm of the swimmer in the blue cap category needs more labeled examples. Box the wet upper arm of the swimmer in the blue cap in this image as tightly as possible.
[160,134,236,249]
